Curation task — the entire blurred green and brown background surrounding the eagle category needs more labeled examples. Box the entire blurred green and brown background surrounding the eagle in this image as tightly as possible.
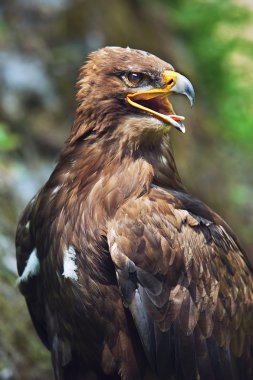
[0,0,253,380]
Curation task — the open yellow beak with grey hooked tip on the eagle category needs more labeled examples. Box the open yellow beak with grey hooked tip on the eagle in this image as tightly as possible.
[126,70,195,133]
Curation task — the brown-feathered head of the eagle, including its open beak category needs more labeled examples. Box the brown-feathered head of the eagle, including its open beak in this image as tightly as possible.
[72,47,195,144]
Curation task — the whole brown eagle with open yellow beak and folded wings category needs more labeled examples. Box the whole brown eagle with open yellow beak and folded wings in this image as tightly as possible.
[16,47,253,380]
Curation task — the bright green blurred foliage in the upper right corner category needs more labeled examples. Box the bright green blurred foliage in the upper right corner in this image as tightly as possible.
[161,0,253,152]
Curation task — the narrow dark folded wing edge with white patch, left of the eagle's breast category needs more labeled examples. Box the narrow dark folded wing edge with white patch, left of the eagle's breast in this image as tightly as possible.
[16,197,74,380]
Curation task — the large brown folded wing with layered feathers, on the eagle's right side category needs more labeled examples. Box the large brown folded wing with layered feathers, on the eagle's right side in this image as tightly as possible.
[108,188,253,380]
